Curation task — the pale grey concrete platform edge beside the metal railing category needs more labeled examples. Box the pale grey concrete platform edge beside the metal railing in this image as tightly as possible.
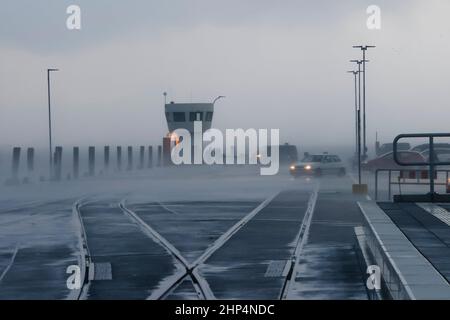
[358,201,450,300]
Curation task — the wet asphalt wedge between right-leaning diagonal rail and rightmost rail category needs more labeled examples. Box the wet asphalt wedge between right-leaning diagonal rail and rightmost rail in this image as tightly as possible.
[200,191,311,299]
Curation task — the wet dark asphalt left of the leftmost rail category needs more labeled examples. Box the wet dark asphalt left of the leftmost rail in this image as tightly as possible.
[0,199,79,300]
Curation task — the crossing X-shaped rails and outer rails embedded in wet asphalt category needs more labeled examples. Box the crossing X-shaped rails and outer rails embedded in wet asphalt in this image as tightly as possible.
[72,191,317,300]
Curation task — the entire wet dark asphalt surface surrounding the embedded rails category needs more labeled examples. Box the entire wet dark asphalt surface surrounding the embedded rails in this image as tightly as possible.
[0,172,386,299]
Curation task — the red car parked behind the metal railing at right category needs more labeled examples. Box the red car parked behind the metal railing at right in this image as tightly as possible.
[361,151,426,171]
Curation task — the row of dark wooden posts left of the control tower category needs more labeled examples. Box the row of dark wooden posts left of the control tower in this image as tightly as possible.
[7,141,170,184]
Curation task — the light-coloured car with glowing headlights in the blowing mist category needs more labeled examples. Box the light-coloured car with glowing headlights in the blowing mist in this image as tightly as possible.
[289,154,345,177]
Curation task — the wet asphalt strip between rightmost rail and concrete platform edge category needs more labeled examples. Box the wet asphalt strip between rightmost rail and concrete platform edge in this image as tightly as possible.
[288,192,368,299]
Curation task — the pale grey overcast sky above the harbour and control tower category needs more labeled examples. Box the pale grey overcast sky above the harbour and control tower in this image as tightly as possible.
[0,0,450,146]
